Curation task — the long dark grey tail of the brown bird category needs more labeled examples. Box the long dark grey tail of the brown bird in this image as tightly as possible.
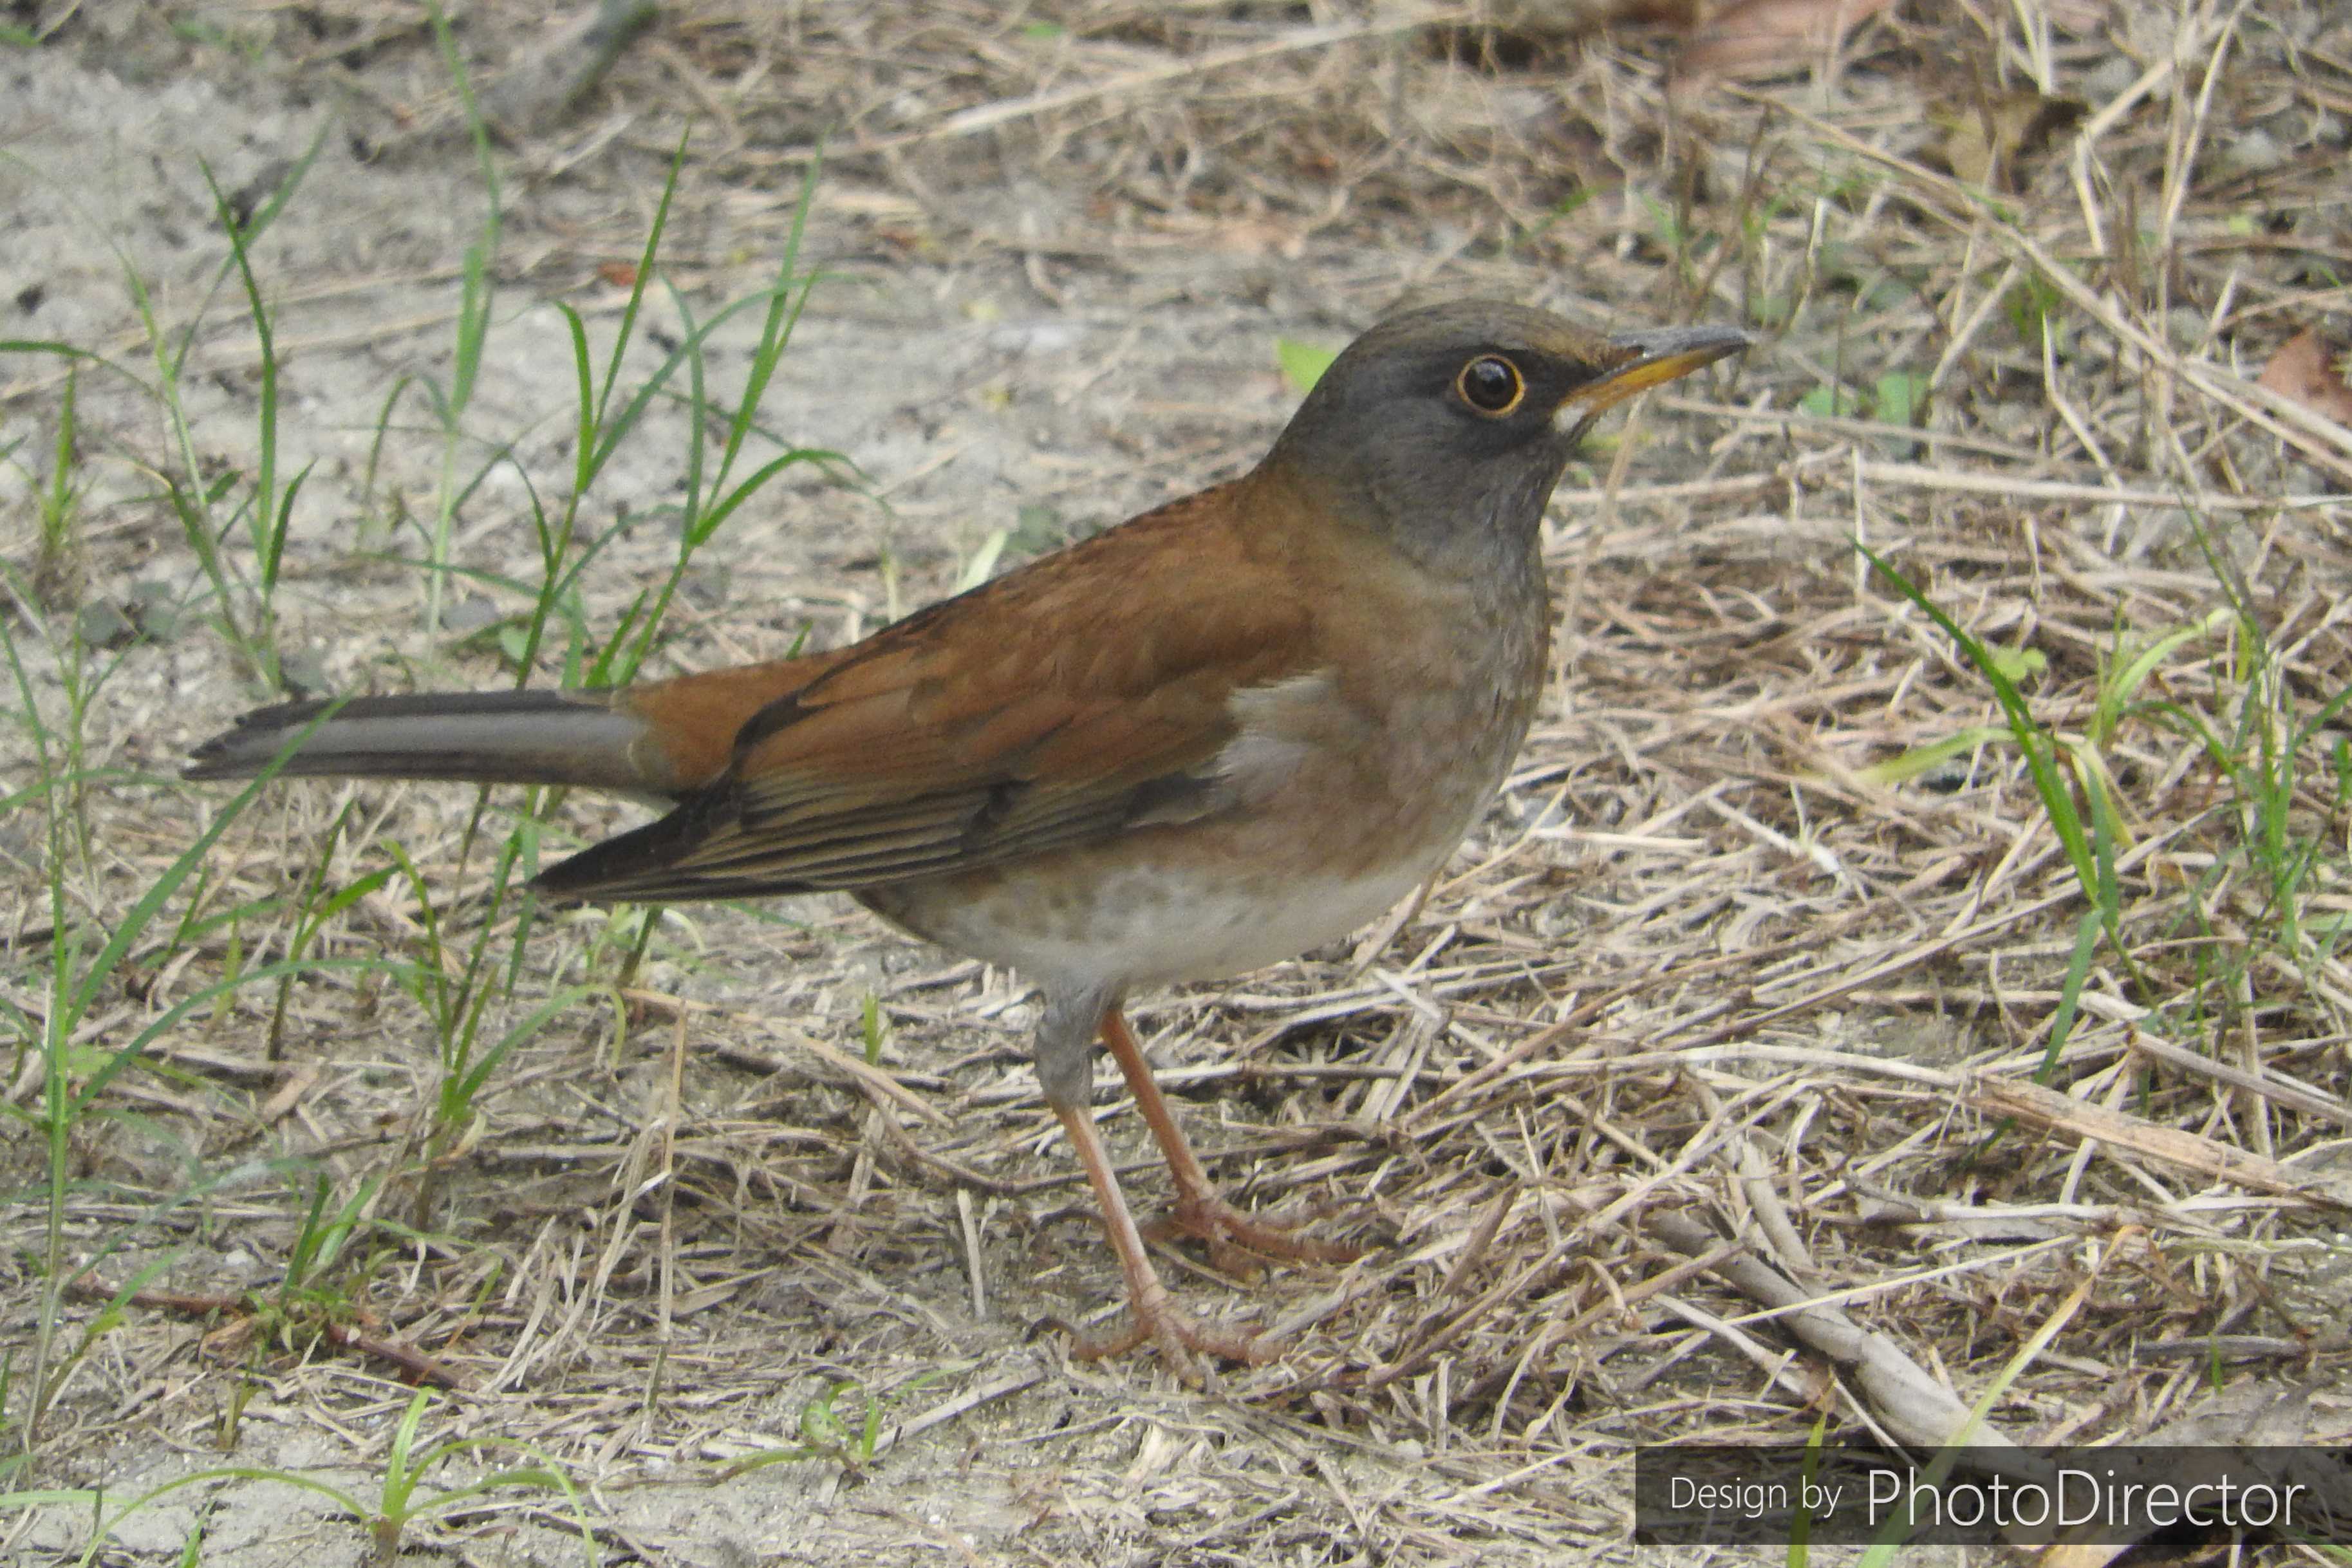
[181,689,668,792]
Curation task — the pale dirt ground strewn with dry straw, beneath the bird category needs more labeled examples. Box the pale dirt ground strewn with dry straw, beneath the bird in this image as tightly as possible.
[14,3,2352,1568]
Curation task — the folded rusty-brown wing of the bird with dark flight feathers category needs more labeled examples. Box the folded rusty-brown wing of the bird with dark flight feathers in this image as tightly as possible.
[541,487,1315,898]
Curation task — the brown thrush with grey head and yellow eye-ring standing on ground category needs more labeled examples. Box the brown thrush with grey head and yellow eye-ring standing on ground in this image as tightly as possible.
[183,299,1750,1382]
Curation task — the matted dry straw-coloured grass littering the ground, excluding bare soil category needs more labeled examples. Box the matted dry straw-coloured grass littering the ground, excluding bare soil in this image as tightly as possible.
[0,3,2352,1563]
